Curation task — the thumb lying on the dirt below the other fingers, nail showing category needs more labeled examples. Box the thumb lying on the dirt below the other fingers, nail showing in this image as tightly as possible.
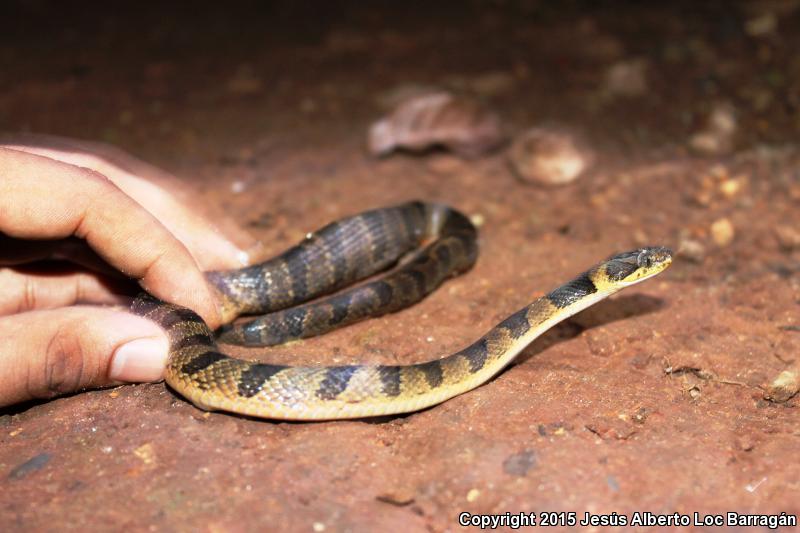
[0,307,169,406]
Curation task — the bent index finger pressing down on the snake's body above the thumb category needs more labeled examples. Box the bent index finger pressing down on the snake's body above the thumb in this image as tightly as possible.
[0,148,219,327]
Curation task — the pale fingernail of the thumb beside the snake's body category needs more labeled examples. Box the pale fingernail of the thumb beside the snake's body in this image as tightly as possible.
[109,338,169,382]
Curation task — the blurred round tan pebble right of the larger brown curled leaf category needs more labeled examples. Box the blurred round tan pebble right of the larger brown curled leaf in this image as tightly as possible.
[508,128,591,185]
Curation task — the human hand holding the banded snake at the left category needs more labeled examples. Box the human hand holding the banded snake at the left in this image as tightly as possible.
[0,137,255,406]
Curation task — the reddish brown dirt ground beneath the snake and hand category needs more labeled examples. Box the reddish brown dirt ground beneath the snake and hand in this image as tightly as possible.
[0,2,800,532]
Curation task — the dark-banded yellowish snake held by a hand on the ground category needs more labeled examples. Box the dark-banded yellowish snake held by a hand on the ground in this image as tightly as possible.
[131,201,672,420]
